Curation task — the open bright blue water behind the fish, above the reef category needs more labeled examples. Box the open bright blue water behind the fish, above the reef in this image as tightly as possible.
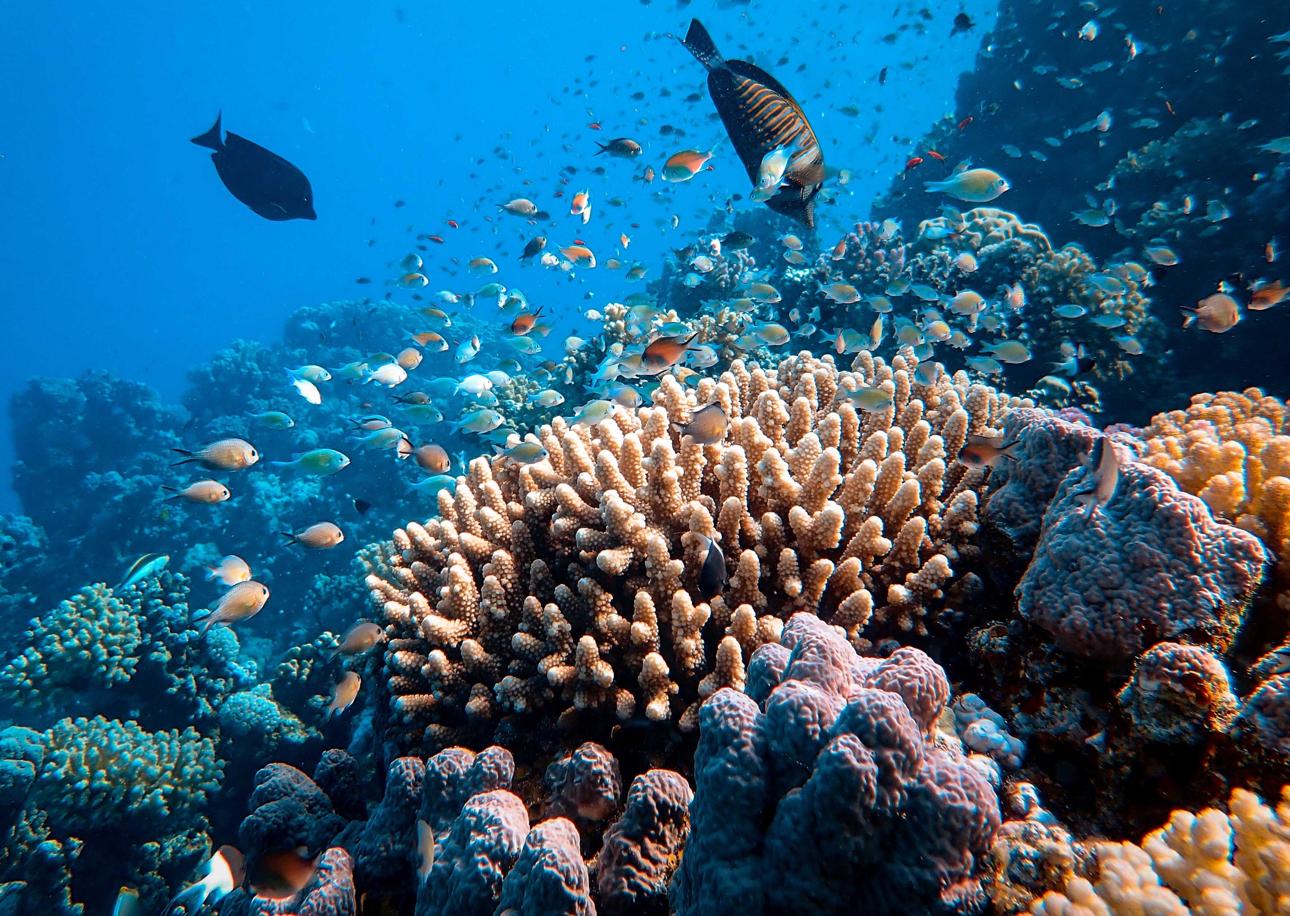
[0,0,993,510]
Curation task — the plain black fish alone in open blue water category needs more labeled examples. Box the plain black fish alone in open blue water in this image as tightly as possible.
[192,115,317,221]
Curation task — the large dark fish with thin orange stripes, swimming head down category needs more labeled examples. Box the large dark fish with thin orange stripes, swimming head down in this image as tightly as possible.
[681,19,824,227]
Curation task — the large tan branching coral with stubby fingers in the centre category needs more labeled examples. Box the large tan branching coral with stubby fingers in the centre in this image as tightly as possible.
[364,352,1015,752]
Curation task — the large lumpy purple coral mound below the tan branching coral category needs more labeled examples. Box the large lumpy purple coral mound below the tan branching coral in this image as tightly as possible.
[671,614,1000,916]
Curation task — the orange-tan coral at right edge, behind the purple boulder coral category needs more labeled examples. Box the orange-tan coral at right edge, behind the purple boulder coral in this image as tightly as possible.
[1140,388,1290,610]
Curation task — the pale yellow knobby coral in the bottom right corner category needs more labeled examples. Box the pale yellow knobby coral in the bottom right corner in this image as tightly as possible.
[1029,788,1290,916]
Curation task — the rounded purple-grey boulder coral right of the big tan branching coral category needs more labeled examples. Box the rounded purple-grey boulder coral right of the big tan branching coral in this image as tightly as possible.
[1017,440,1265,662]
